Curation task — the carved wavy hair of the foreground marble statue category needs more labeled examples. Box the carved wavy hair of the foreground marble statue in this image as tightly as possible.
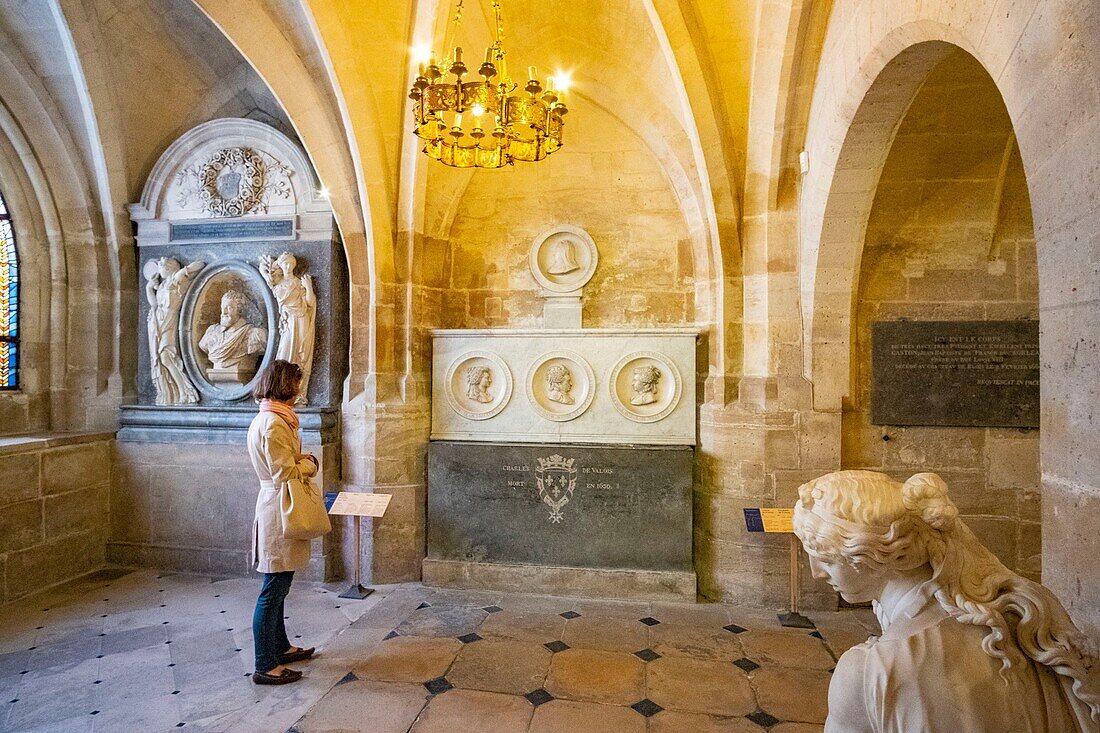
[794,471,1100,720]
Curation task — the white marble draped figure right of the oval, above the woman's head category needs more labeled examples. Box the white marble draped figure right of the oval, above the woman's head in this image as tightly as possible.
[260,252,317,402]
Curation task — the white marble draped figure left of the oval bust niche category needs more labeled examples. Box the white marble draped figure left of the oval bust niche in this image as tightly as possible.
[144,258,206,405]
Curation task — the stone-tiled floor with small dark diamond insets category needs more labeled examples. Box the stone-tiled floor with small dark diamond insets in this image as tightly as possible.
[0,571,876,733]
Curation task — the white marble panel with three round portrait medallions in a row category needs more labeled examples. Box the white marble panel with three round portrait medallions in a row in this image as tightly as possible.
[431,328,699,446]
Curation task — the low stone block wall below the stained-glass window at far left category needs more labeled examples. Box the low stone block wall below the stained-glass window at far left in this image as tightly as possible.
[0,433,114,602]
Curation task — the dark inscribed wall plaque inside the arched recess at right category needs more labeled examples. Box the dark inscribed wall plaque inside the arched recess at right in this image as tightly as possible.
[871,320,1038,427]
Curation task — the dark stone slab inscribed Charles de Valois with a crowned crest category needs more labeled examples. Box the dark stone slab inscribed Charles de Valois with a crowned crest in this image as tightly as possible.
[428,440,693,570]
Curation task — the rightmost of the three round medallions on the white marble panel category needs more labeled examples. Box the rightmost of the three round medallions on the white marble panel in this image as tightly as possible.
[607,351,682,423]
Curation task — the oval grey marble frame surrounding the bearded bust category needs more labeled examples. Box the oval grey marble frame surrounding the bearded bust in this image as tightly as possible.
[179,260,278,402]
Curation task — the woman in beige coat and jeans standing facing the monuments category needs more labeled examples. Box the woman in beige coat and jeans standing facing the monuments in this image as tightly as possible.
[249,360,317,685]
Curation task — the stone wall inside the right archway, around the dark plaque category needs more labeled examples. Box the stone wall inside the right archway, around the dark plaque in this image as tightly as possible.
[840,52,1042,578]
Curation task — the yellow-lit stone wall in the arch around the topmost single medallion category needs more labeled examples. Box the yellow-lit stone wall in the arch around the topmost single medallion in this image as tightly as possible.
[437,105,695,328]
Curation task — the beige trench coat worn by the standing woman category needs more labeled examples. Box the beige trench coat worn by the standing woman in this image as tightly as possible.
[249,413,317,572]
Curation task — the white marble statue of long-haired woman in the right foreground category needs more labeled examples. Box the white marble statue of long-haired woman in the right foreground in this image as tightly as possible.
[794,471,1100,733]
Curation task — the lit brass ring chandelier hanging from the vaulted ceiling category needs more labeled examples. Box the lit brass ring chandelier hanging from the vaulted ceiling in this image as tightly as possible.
[409,0,569,168]
